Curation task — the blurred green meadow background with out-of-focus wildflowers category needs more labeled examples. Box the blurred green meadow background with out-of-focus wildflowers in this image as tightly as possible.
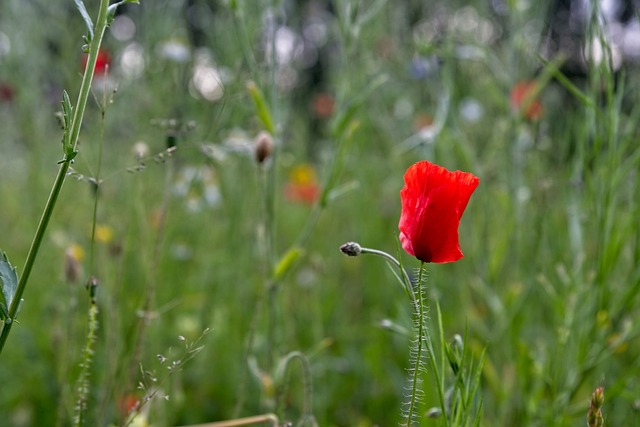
[0,0,640,427]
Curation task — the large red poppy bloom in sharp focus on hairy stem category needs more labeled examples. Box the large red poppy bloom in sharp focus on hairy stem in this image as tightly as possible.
[398,160,480,263]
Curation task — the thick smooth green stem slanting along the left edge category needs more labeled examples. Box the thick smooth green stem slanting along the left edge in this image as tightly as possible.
[0,0,109,354]
